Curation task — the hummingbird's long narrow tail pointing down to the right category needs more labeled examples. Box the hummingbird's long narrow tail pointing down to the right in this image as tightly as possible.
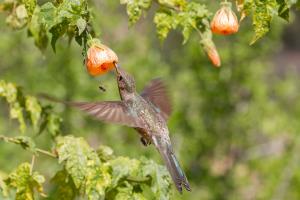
[152,136,191,193]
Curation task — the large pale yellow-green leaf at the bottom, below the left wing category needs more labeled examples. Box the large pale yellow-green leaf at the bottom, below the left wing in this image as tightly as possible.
[56,136,111,199]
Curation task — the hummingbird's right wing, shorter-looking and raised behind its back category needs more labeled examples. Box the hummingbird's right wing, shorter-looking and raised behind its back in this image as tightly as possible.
[141,78,172,120]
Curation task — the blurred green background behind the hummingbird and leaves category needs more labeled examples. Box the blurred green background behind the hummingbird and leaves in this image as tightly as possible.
[0,1,300,200]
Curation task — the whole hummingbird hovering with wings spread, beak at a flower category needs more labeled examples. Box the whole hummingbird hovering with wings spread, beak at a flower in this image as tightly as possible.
[46,65,191,193]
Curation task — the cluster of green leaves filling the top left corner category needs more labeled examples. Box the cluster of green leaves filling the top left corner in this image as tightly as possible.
[0,0,92,51]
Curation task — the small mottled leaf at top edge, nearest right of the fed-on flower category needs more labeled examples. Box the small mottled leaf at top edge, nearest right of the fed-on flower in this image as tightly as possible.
[120,0,152,25]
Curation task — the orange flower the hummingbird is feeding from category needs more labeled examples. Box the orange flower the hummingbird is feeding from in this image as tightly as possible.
[86,43,118,76]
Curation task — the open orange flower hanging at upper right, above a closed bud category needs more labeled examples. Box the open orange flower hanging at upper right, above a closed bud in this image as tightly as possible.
[210,2,239,35]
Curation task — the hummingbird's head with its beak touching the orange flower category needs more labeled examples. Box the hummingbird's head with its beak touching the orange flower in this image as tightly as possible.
[116,65,135,93]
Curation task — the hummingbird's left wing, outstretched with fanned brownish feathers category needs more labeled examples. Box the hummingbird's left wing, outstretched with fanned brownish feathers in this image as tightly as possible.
[69,101,142,128]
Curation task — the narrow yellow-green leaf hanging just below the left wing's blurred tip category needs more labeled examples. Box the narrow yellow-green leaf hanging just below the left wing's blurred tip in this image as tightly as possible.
[25,96,42,130]
